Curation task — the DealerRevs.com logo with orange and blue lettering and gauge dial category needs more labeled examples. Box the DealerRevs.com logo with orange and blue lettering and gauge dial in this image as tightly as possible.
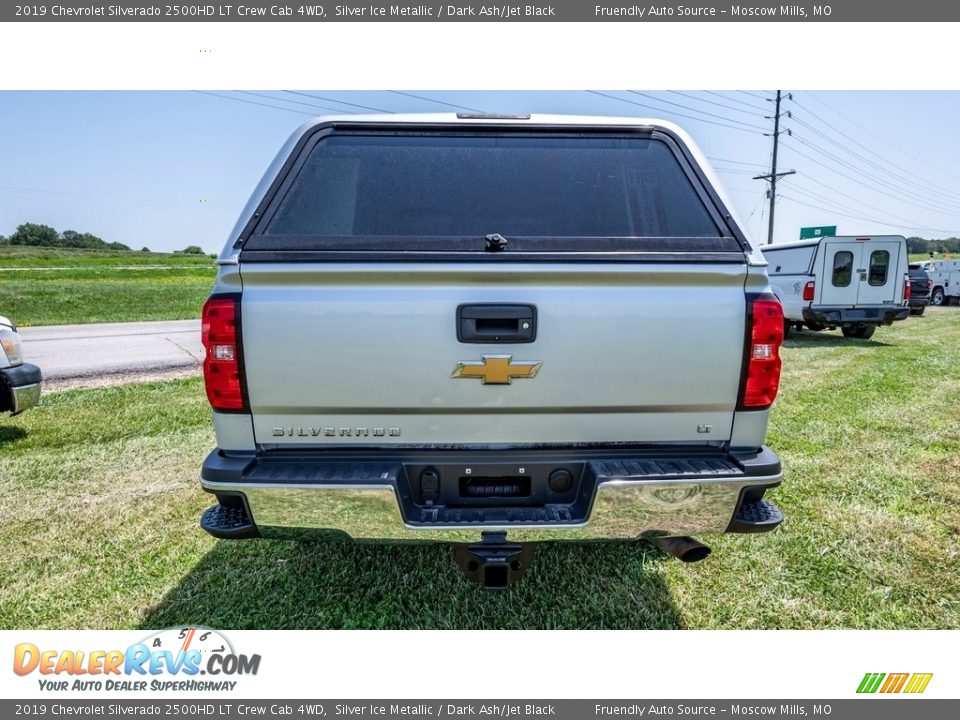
[13,627,260,692]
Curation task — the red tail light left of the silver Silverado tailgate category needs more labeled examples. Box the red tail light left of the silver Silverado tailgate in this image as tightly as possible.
[202,297,247,410]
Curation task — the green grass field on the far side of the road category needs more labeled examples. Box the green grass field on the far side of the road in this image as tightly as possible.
[0,246,216,327]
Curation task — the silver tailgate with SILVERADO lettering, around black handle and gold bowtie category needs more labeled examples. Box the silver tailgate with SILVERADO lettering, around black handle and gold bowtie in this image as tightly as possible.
[241,262,746,447]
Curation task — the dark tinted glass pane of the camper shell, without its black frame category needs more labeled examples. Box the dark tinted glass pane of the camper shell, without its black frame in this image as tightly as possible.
[266,135,721,238]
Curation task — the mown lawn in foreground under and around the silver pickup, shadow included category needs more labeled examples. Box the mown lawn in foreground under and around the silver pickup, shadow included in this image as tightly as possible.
[0,308,960,628]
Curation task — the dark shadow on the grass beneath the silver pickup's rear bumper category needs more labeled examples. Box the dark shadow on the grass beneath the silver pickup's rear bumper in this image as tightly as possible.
[141,540,682,629]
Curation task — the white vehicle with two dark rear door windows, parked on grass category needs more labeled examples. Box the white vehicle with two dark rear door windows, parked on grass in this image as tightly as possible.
[762,235,910,338]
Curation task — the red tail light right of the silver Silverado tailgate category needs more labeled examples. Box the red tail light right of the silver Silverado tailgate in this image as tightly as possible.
[740,297,783,410]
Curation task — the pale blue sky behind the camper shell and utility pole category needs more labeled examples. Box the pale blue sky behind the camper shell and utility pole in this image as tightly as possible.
[0,90,960,252]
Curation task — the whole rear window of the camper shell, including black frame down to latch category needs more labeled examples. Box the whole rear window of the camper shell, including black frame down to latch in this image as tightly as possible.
[244,131,742,257]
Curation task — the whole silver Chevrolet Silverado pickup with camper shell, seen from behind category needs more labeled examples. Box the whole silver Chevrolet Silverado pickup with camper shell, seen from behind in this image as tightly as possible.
[201,115,784,588]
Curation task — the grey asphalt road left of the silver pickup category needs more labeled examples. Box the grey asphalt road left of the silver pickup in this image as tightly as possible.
[19,320,203,380]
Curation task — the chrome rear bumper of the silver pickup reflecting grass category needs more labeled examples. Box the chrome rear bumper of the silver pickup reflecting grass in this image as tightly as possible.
[201,450,782,542]
